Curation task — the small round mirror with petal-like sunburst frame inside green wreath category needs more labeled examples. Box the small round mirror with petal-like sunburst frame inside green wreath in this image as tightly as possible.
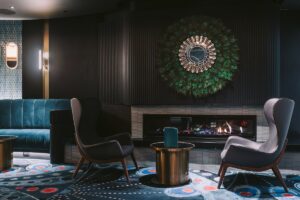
[178,35,217,74]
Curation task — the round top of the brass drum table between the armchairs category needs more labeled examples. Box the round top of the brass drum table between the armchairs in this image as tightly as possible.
[150,141,195,152]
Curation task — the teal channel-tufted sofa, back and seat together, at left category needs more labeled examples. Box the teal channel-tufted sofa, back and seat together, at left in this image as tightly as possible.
[0,99,70,152]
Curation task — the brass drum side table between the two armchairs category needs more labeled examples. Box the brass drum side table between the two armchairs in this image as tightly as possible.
[150,142,195,186]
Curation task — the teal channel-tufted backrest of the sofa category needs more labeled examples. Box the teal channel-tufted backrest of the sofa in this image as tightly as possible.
[0,99,71,129]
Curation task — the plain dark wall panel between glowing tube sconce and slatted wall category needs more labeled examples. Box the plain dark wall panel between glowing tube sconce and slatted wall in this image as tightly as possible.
[49,16,98,98]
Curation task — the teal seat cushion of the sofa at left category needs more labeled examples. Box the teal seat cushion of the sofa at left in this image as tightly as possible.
[0,129,50,151]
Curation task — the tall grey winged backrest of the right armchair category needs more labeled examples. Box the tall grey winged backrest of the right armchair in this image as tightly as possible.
[260,98,295,156]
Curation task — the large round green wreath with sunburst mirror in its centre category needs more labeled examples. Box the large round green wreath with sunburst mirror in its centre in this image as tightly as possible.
[157,15,239,98]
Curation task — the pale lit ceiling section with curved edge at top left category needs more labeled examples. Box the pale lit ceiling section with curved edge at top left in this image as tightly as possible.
[0,0,121,20]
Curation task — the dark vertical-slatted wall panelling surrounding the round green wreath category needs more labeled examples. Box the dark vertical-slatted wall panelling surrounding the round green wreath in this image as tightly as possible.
[98,6,279,106]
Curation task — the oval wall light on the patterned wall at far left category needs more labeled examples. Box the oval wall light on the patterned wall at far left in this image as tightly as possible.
[5,42,18,69]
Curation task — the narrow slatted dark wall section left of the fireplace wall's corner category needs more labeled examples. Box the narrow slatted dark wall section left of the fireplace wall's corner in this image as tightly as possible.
[98,13,128,104]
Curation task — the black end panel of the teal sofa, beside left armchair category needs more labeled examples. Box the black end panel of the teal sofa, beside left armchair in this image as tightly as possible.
[50,110,74,163]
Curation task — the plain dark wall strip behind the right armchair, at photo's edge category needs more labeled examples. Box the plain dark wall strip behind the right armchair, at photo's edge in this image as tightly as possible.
[280,11,300,135]
